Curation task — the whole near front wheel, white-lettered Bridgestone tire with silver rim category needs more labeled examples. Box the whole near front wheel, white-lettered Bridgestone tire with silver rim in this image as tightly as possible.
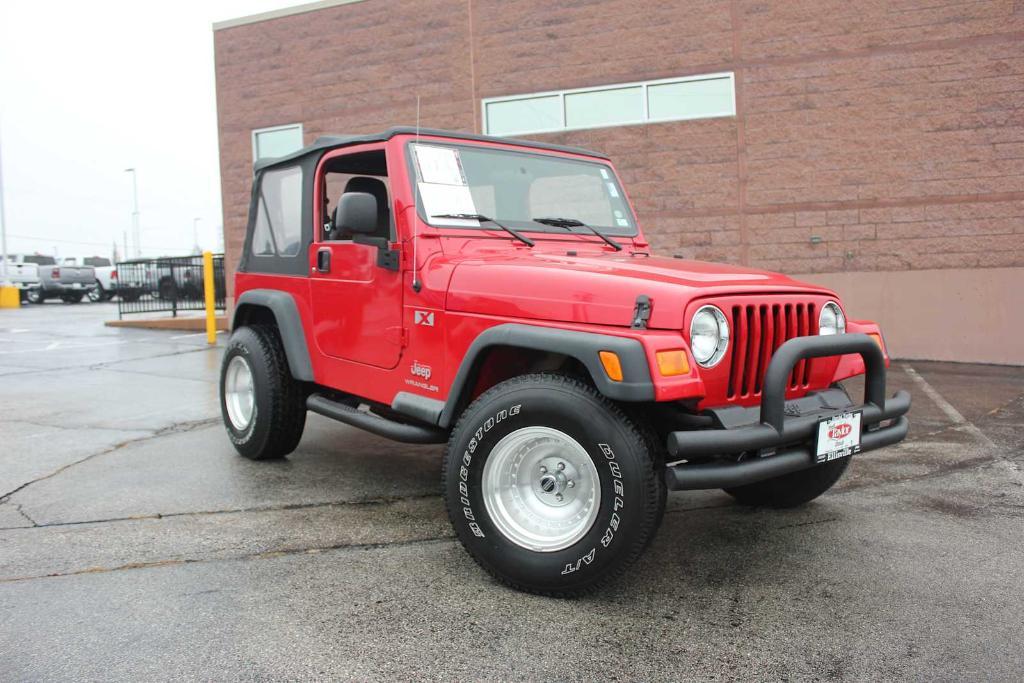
[441,374,665,597]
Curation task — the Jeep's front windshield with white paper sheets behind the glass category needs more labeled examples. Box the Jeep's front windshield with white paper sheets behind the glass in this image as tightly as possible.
[410,142,637,236]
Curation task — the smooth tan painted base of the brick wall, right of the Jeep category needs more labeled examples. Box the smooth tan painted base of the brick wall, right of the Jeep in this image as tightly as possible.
[794,268,1024,366]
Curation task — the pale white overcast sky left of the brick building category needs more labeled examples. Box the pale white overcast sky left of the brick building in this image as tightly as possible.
[0,0,301,256]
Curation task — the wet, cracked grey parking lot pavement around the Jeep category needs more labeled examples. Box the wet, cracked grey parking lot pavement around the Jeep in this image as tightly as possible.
[0,303,1024,681]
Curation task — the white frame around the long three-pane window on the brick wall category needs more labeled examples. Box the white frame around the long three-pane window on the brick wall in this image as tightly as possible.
[480,72,736,136]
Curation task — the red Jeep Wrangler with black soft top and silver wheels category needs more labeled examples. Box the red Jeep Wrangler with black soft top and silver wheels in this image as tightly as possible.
[220,128,910,596]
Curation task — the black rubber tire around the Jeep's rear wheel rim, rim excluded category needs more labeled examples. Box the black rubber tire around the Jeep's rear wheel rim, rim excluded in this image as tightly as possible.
[220,325,306,460]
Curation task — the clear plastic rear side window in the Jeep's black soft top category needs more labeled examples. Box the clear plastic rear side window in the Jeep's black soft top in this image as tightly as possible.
[252,166,302,256]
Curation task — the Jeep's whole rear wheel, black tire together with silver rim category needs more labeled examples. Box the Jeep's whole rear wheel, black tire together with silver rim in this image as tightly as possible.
[220,325,306,460]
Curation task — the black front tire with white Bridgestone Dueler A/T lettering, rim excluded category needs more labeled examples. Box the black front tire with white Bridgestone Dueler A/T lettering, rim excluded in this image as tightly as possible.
[441,374,665,597]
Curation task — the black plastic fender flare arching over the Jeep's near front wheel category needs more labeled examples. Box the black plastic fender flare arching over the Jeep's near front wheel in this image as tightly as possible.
[391,323,654,429]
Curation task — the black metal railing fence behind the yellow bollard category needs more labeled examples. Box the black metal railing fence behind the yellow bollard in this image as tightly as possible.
[117,254,227,317]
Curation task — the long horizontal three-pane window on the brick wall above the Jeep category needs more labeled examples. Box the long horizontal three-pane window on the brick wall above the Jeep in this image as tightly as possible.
[483,73,736,135]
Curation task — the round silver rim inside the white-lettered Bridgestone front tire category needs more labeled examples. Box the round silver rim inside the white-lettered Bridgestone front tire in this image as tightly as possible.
[482,427,601,553]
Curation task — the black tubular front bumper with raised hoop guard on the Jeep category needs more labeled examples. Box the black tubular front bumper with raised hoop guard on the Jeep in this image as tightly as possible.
[666,334,910,490]
